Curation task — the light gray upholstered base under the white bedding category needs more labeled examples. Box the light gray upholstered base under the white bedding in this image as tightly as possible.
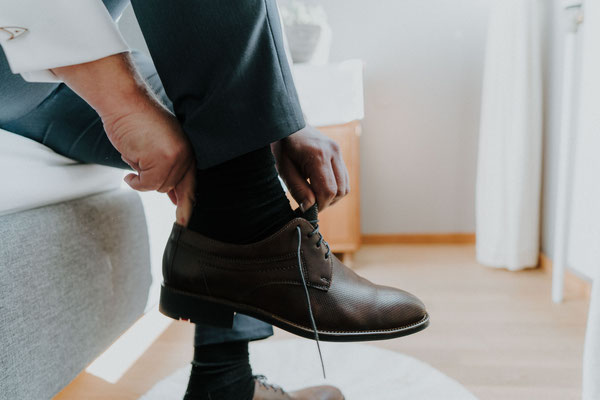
[0,190,151,400]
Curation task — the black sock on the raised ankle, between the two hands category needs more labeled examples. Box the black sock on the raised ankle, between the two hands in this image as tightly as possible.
[188,146,294,244]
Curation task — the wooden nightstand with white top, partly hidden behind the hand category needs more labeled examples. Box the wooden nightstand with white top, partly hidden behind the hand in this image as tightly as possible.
[293,60,364,265]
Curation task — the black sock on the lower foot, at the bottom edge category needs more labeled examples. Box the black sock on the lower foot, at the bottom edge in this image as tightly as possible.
[184,342,254,400]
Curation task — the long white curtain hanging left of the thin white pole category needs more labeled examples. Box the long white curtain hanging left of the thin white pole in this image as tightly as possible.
[476,0,542,270]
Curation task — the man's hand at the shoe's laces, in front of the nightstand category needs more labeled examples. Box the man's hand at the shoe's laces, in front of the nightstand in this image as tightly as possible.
[271,126,350,210]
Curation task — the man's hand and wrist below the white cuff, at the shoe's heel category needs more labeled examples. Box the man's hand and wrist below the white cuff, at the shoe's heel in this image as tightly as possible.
[52,54,195,225]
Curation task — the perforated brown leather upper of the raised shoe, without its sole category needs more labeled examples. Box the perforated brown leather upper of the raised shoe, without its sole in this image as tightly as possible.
[164,214,428,340]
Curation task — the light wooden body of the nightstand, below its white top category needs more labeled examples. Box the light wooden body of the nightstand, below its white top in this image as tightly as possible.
[288,121,361,266]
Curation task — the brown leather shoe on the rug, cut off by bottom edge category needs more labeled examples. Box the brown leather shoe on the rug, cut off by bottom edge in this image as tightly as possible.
[252,375,344,400]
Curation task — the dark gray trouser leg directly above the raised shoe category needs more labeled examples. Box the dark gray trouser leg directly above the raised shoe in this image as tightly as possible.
[127,0,304,168]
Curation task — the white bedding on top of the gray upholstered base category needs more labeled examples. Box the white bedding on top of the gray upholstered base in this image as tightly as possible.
[0,129,123,215]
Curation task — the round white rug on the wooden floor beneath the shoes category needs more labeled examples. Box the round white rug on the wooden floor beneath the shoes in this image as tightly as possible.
[140,339,476,400]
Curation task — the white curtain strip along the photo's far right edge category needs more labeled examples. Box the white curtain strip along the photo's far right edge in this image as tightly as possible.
[568,0,600,400]
